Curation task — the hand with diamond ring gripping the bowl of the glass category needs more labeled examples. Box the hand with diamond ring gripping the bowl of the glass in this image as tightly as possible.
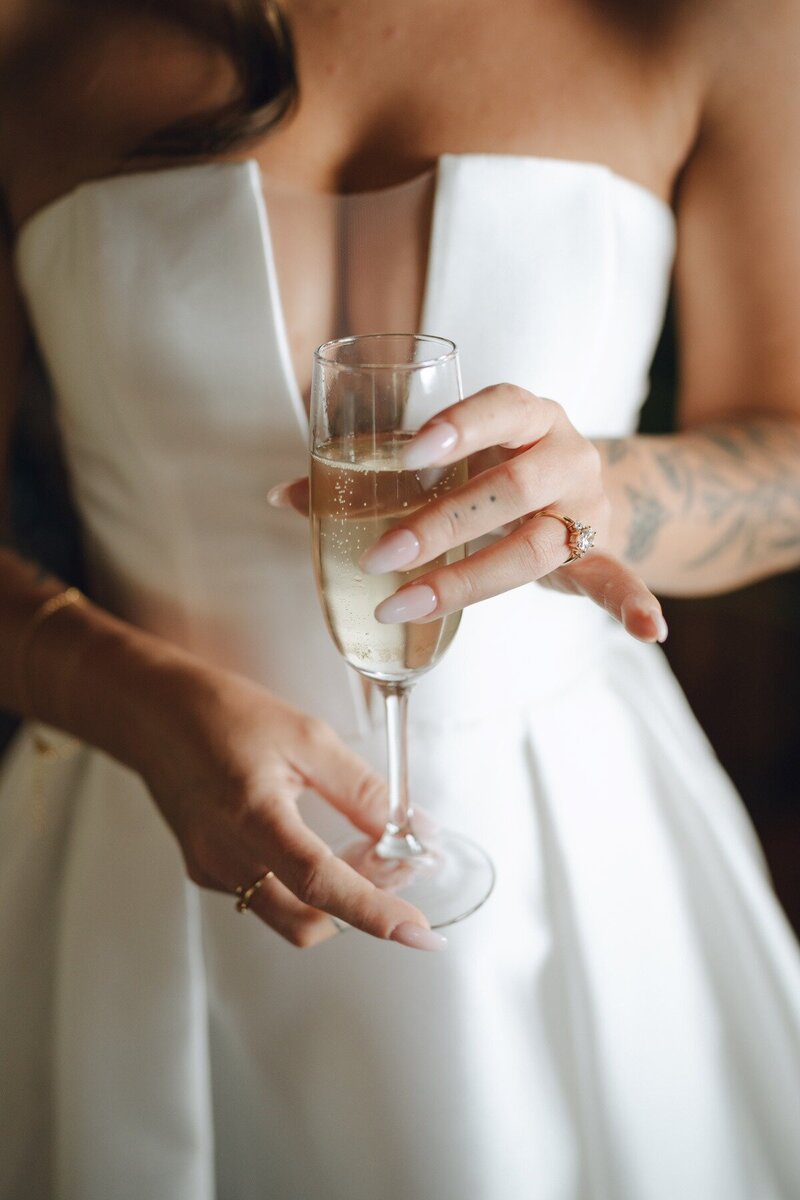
[272,384,667,642]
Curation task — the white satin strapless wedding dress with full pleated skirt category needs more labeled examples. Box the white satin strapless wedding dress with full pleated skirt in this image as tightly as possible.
[0,155,800,1200]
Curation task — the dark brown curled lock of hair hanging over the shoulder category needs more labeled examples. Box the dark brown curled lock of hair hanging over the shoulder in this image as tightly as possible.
[136,0,299,157]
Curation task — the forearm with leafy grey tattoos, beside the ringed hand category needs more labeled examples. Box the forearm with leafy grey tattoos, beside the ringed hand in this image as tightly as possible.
[597,416,800,595]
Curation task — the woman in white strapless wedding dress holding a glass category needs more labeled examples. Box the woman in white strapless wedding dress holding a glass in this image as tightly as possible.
[0,0,800,1200]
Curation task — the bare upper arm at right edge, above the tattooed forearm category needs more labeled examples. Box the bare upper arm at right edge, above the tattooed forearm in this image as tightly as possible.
[676,0,800,420]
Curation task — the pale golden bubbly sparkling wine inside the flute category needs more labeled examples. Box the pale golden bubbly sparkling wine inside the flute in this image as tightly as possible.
[311,433,467,682]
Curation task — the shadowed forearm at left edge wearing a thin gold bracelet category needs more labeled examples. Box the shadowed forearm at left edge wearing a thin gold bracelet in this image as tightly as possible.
[0,550,199,770]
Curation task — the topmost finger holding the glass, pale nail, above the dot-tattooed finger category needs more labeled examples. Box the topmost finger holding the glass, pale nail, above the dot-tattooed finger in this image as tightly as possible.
[402,383,563,468]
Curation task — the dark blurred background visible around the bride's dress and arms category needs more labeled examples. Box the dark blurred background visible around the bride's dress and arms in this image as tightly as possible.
[6,314,800,934]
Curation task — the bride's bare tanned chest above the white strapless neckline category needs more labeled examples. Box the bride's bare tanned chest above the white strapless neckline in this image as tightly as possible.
[259,0,696,198]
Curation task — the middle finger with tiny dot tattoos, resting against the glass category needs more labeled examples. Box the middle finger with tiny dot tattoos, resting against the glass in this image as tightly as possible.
[360,439,606,575]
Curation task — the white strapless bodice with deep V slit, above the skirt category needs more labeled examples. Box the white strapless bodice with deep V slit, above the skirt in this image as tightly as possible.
[17,155,674,732]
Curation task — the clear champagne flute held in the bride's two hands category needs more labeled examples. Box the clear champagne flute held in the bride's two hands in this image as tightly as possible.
[309,334,494,929]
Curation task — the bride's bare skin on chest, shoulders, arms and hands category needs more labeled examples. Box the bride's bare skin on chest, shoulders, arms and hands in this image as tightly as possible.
[0,0,800,944]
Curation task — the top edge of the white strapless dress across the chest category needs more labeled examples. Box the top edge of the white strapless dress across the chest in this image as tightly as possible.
[14,151,675,254]
